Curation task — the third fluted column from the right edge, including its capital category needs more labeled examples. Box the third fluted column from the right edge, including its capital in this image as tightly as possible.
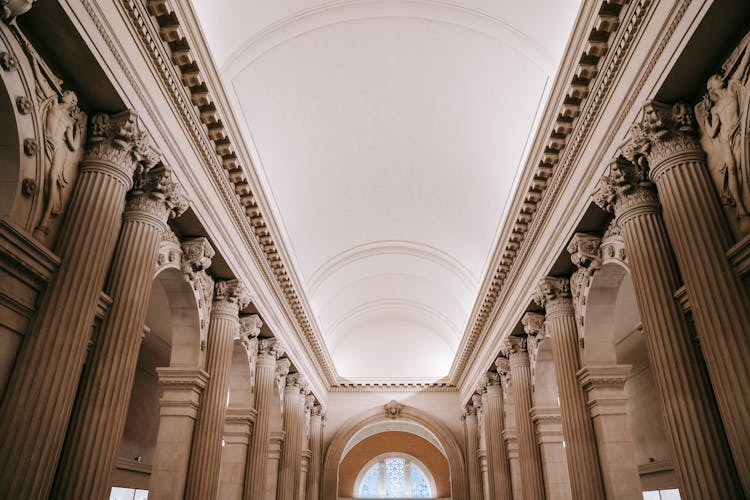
[534,277,604,499]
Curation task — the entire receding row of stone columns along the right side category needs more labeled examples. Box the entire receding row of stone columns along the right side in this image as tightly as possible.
[464,102,750,499]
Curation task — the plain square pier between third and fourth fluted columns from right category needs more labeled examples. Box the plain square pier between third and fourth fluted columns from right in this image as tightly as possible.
[531,407,572,500]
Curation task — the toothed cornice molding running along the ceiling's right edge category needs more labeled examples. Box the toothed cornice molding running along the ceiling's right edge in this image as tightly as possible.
[451,0,640,381]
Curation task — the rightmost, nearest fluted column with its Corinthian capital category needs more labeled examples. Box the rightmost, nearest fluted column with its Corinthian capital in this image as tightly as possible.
[623,101,750,496]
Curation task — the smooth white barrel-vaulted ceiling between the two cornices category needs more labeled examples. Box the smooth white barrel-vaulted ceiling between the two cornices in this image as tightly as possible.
[193,0,580,381]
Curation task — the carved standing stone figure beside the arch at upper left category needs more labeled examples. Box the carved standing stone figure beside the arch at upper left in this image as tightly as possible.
[36,90,86,234]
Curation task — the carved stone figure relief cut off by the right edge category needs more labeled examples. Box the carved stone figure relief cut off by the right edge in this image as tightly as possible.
[695,28,750,234]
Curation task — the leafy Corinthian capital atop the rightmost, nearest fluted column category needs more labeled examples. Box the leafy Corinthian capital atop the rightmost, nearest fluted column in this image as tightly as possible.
[621,101,701,178]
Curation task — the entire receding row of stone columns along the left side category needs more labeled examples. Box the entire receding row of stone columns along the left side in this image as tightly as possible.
[0,111,325,500]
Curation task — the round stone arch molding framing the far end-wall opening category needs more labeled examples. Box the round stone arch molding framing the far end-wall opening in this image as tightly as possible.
[322,405,467,500]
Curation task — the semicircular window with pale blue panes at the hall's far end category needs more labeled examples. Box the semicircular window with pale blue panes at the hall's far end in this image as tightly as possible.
[354,453,435,498]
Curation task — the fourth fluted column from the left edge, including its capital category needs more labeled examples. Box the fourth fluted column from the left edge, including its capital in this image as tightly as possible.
[245,339,277,500]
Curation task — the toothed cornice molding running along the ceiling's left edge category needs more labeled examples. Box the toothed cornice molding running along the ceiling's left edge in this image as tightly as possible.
[106,0,337,384]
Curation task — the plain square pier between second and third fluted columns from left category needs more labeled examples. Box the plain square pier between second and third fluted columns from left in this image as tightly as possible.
[148,367,208,500]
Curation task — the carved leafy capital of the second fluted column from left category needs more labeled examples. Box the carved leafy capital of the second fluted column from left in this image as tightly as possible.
[125,163,189,227]
